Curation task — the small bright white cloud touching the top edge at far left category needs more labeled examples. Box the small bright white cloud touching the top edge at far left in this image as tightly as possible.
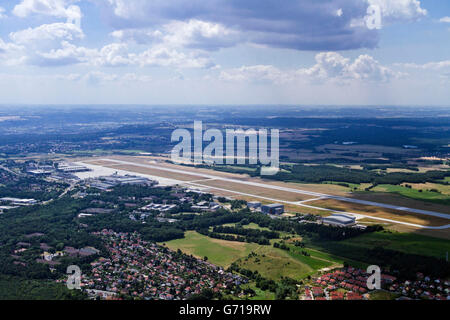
[13,0,82,22]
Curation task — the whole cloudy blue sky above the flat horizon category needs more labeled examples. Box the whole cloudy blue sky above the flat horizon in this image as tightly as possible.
[0,0,450,106]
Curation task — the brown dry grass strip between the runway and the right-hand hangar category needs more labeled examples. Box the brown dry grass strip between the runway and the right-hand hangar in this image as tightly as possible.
[309,199,448,226]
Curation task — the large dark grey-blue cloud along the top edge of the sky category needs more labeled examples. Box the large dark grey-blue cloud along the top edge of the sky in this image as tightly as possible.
[104,0,378,50]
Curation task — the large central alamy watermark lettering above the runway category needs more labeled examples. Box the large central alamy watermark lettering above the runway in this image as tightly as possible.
[171,121,280,175]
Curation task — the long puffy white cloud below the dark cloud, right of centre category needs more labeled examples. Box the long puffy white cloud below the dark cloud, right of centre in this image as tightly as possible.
[220,52,402,84]
